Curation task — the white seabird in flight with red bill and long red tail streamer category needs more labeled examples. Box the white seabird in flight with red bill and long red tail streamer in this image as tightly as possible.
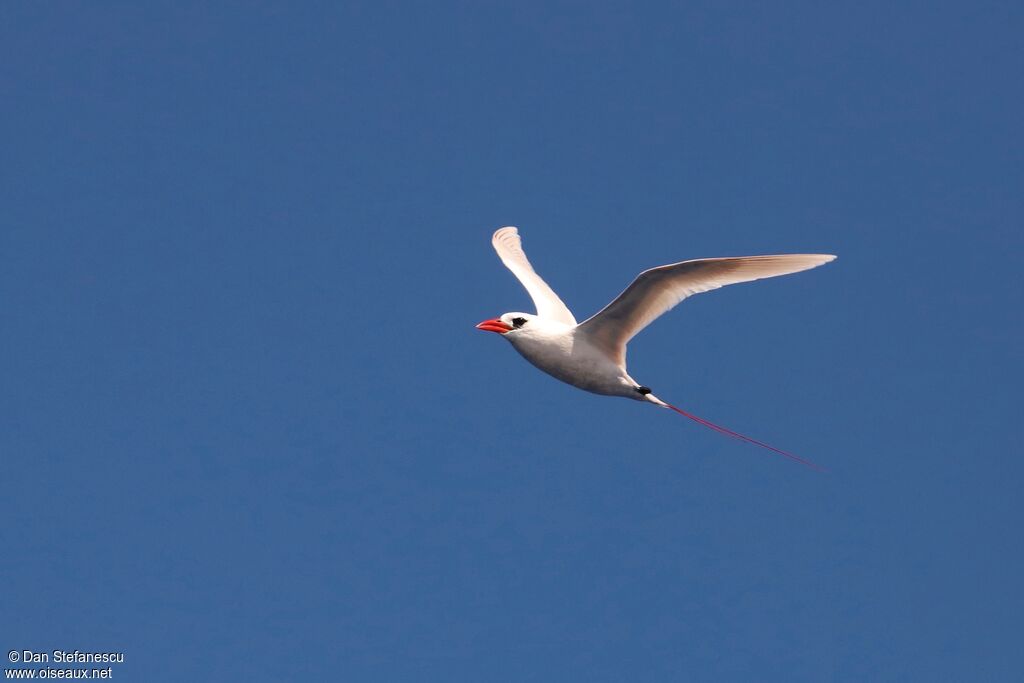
[476,226,836,468]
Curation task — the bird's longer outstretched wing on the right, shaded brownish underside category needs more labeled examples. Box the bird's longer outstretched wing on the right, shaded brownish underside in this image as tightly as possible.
[579,254,836,365]
